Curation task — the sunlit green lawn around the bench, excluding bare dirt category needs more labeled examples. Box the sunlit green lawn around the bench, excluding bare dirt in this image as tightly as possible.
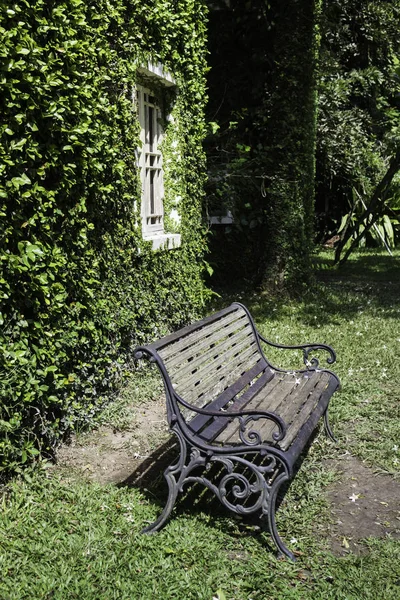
[0,251,400,600]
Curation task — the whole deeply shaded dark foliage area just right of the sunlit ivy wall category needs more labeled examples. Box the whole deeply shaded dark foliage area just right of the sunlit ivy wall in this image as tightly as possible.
[208,0,319,290]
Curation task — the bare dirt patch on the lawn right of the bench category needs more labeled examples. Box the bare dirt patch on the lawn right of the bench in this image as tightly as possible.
[327,454,400,555]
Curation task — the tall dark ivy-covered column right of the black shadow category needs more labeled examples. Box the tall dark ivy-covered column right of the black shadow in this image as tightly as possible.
[261,0,319,292]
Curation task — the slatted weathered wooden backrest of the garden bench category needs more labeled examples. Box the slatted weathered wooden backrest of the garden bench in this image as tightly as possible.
[151,304,266,408]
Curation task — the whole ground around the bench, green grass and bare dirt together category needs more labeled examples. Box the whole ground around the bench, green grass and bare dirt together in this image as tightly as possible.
[0,249,400,600]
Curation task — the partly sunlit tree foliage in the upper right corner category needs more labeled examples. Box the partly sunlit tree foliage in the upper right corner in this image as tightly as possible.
[317,0,400,238]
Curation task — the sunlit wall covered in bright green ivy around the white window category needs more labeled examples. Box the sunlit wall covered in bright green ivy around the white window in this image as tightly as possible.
[0,0,206,475]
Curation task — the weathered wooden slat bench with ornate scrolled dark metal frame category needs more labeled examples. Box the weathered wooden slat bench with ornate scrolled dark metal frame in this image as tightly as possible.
[134,302,340,560]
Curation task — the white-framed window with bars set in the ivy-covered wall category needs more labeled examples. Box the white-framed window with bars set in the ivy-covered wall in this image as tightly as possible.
[136,65,181,249]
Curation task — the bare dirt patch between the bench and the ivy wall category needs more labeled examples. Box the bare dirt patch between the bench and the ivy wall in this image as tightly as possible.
[55,396,170,483]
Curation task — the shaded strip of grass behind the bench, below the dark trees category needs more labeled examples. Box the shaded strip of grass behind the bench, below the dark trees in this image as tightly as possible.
[212,251,400,330]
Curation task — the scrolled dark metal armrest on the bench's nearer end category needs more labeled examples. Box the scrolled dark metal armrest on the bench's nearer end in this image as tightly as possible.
[175,394,287,446]
